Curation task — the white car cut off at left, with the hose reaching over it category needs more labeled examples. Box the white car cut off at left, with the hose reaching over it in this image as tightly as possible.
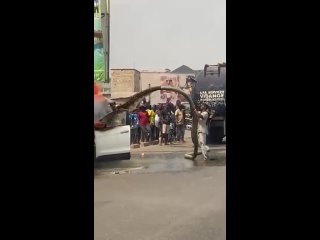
[94,97,131,161]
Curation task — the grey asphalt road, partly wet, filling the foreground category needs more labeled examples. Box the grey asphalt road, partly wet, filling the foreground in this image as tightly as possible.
[94,152,226,240]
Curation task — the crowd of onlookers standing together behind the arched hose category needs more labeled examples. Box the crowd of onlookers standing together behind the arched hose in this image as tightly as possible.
[129,99,186,145]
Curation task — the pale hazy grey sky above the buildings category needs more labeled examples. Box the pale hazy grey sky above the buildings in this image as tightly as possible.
[110,0,226,71]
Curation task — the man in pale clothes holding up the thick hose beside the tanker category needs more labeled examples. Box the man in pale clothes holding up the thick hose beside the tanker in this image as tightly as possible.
[195,103,209,161]
